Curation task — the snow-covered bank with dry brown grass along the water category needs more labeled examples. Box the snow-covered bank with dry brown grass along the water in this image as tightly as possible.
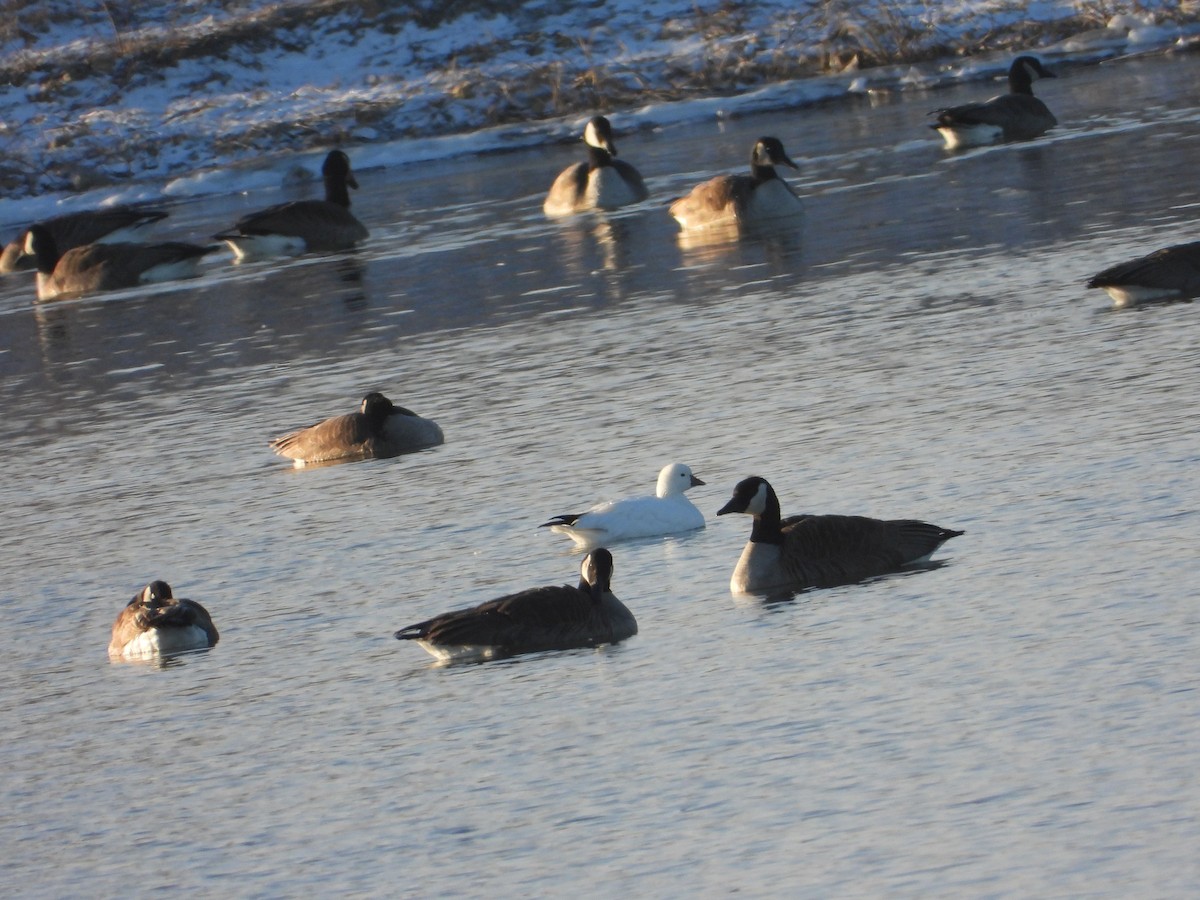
[0,0,1200,224]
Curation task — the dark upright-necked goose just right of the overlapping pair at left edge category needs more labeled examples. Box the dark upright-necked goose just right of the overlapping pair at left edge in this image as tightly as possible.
[212,150,368,260]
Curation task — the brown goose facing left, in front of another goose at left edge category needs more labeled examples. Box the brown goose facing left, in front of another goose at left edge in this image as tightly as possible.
[25,224,220,300]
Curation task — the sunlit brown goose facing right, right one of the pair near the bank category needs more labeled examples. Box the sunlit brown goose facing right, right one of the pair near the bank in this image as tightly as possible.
[671,138,804,229]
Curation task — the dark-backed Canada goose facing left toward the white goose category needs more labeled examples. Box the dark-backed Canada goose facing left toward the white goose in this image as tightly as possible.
[716,476,962,594]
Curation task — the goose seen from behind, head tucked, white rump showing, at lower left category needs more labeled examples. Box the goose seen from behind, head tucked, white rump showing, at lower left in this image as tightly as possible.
[108,581,220,659]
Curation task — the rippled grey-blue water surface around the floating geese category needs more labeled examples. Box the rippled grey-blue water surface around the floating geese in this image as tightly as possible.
[0,58,1200,896]
